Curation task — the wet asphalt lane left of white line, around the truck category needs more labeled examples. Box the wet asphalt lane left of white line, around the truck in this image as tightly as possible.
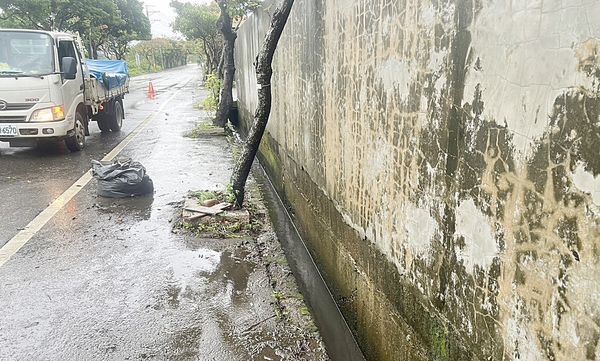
[0,65,190,243]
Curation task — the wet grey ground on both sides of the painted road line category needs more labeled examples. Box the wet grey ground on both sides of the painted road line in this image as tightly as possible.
[0,66,327,360]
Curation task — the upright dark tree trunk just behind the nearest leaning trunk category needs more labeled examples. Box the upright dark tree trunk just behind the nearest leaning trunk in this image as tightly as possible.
[213,0,237,128]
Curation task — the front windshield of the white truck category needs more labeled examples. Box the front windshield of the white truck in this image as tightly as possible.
[0,31,54,77]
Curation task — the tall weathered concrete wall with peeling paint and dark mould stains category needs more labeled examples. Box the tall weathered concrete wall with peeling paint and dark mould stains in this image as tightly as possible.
[236,0,600,360]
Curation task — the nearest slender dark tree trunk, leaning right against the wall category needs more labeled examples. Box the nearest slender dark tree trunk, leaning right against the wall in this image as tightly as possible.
[231,0,294,207]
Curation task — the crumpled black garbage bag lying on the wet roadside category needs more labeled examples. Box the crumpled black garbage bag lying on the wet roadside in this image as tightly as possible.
[92,159,154,198]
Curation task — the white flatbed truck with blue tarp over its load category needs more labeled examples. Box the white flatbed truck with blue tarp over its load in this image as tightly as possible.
[0,29,129,152]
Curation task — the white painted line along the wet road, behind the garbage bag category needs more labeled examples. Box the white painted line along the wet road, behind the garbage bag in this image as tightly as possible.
[0,87,187,267]
